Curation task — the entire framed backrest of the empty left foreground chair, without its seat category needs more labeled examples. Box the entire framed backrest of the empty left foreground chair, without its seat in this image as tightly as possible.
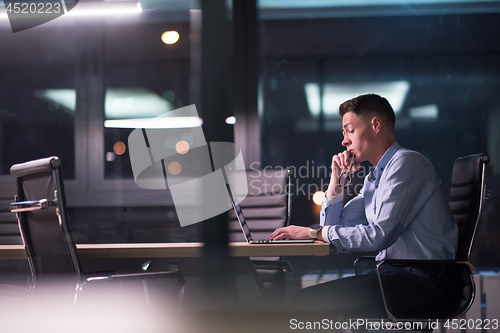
[10,156,81,285]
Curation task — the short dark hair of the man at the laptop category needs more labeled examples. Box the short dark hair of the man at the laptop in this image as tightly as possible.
[339,94,396,133]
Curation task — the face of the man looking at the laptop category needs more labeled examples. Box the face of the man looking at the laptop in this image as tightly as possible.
[342,112,375,162]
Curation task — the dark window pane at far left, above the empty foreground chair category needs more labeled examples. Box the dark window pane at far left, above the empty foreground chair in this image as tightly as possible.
[0,27,76,179]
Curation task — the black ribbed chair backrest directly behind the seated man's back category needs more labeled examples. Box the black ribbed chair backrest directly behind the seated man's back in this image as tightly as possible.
[450,153,490,262]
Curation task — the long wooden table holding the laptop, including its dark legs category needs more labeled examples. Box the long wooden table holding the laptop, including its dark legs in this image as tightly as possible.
[0,242,330,302]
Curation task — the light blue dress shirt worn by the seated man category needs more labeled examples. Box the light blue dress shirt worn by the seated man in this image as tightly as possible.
[320,142,458,260]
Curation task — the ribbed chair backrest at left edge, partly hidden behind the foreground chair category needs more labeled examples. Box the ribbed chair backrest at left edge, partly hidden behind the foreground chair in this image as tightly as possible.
[0,175,23,245]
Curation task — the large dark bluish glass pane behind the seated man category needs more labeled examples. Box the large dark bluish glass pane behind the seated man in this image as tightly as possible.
[259,0,500,268]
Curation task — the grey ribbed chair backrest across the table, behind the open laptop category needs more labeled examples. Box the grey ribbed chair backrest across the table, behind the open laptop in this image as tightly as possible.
[229,169,293,241]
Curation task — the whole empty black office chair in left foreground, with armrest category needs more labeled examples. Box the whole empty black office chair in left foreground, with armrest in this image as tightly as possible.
[10,157,185,305]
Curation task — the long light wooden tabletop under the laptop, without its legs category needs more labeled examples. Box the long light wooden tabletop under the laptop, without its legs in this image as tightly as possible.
[0,242,330,259]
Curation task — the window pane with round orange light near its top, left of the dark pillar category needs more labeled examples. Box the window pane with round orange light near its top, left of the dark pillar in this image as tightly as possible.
[103,23,190,179]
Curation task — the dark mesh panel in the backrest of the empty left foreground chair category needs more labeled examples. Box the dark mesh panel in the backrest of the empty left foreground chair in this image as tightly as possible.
[11,158,79,281]
